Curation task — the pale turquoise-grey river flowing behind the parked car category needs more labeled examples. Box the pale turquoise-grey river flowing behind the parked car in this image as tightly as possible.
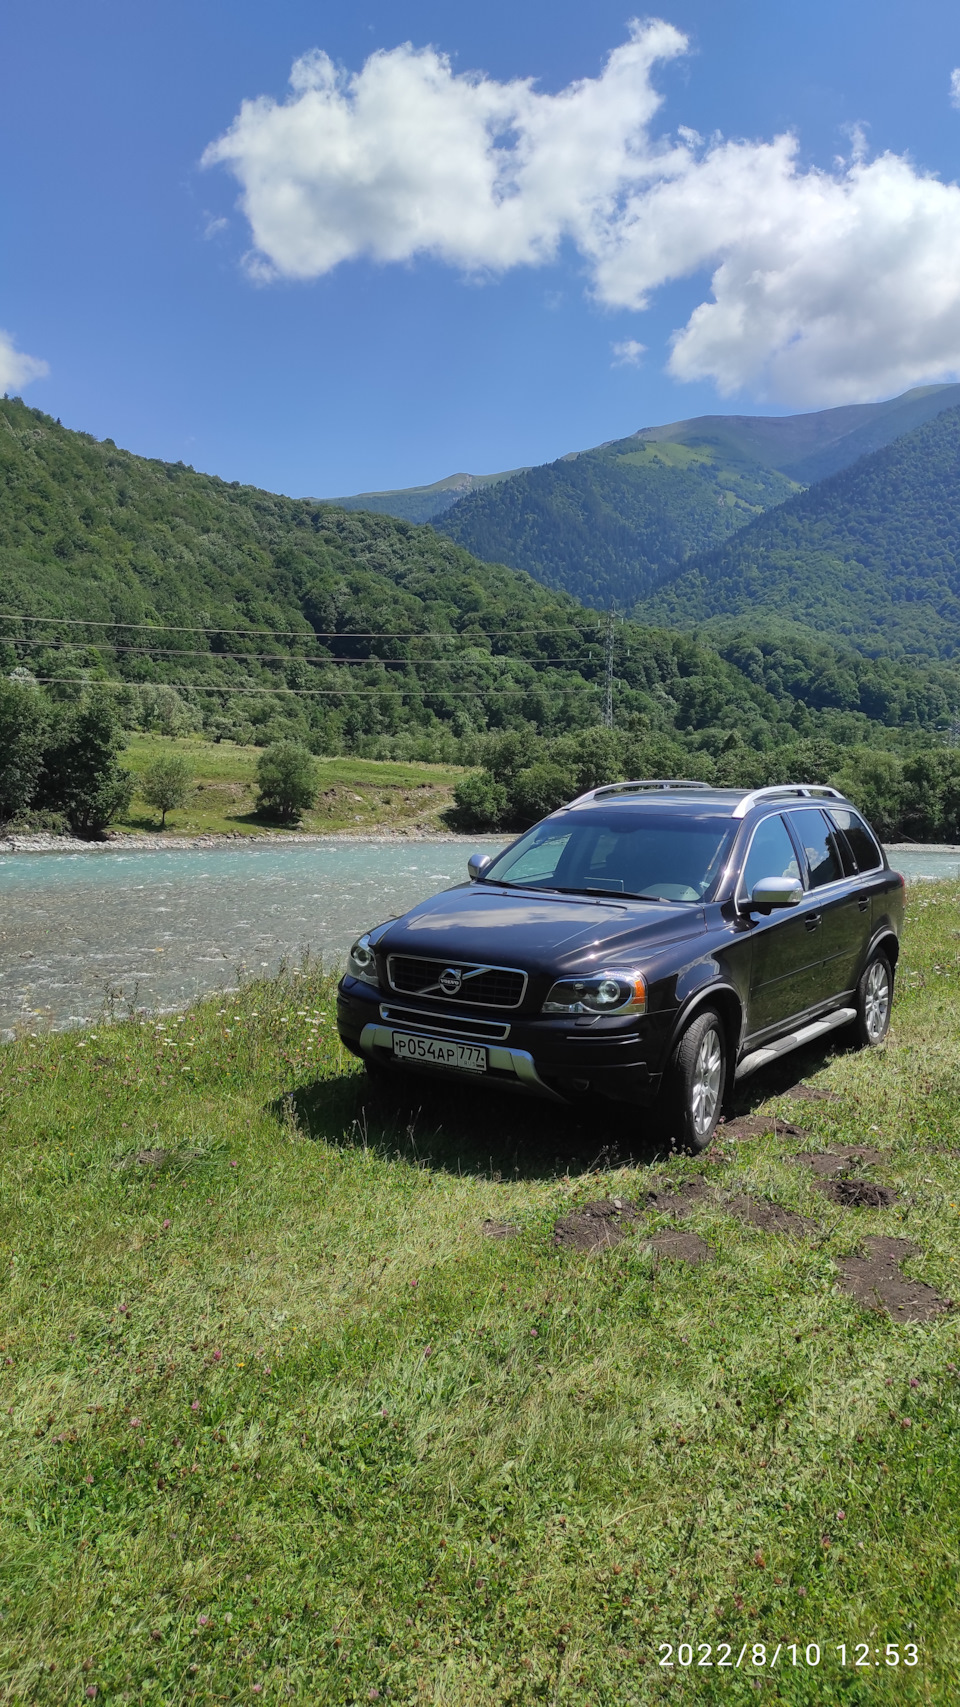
[0,838,960,1040]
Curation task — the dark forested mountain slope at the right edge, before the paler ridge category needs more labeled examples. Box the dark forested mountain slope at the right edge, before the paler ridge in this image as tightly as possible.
[639,408,960,659]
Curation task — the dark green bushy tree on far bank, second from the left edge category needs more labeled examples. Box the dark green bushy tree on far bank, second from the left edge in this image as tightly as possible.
[38,693,137,836]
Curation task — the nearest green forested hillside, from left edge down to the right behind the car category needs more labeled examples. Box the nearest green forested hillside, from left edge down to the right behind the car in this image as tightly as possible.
[0,399,960,778]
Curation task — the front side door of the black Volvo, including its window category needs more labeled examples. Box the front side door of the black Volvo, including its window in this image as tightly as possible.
[738,813,822,1038]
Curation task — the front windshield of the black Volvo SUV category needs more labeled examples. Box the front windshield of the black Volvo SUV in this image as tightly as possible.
[483,804,736,901]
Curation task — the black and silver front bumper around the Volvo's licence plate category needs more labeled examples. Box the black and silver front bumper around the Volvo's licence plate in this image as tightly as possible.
[337,980,661,1108]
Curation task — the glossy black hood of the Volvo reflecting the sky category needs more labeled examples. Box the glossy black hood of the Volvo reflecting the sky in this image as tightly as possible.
[372,883,705,971]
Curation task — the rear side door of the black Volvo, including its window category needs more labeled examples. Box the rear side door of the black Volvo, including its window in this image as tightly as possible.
[787,806,854,1002]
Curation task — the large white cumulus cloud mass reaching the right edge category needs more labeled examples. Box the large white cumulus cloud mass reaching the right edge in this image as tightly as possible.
[203,19,960,405]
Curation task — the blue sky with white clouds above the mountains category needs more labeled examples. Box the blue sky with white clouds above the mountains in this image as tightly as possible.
[0,0,960,495]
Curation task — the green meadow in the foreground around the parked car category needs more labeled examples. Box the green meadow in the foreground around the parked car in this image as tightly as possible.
[0,884,960,1707]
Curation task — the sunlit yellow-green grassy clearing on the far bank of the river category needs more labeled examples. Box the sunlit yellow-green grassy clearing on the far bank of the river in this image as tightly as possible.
[111,736,463,835]
